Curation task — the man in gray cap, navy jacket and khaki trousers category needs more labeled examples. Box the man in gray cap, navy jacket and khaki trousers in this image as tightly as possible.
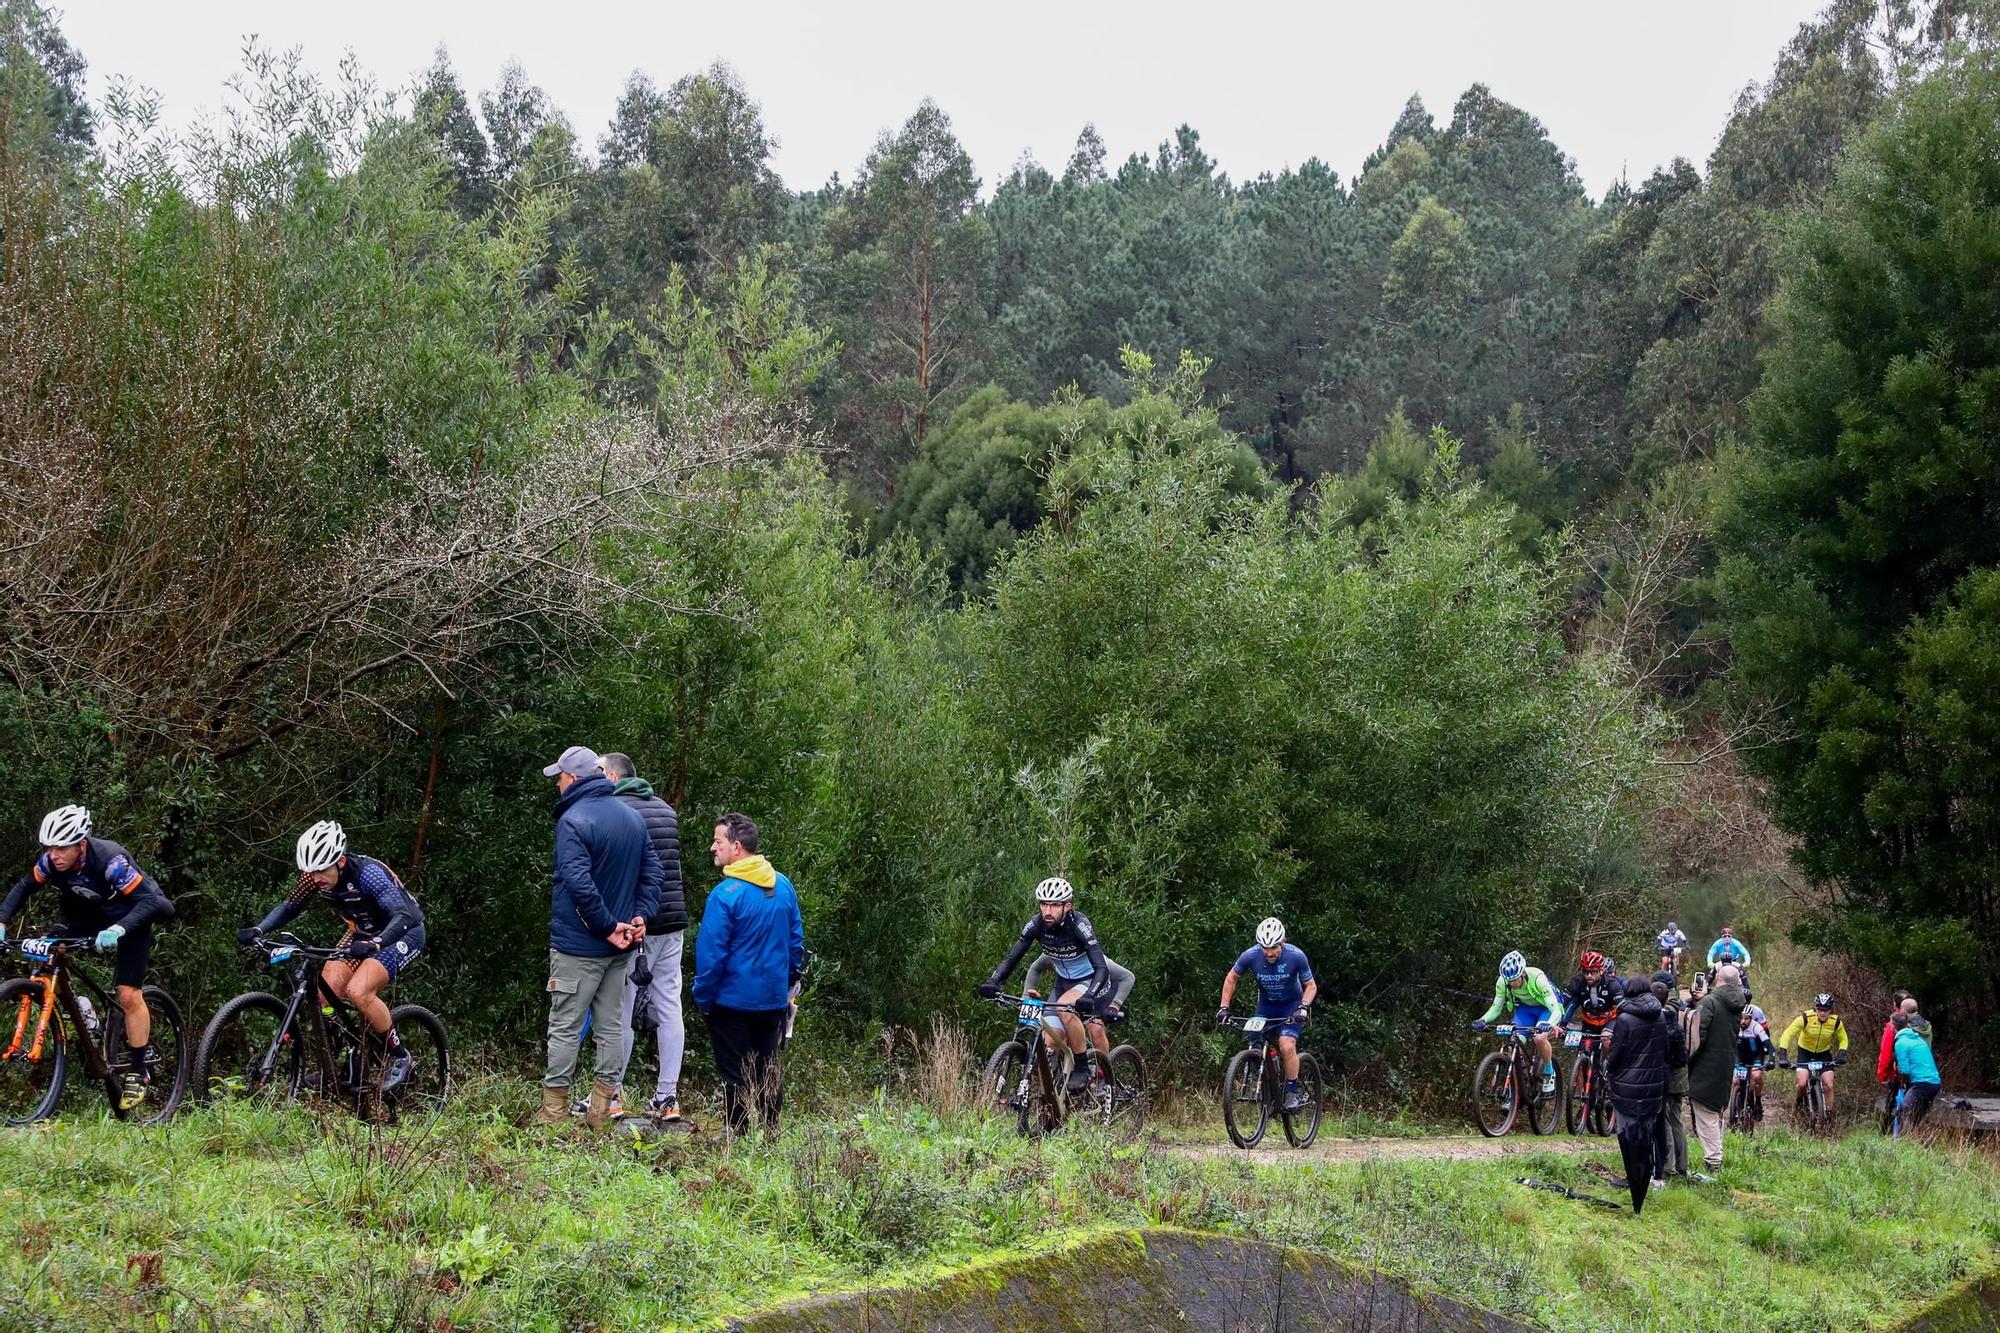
[536,745,660,1129]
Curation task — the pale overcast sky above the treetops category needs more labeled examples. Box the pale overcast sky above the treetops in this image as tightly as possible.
[62,0,1824,194]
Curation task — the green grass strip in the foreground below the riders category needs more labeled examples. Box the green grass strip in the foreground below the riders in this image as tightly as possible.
[0,1083,2000,1333]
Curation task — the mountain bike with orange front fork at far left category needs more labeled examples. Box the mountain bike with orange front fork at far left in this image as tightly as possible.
[0,935,188,1125]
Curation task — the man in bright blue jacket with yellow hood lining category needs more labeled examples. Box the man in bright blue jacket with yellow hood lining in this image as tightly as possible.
[692,815,806,1135]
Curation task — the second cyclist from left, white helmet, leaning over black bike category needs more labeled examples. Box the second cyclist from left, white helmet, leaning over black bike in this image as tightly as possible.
[236,819,424,1089]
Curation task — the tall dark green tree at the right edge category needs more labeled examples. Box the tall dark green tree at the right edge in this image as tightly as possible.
[1722,60,2000,1048]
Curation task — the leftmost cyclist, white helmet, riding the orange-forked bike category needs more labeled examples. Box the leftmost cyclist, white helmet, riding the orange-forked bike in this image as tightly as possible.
[0,805,174,1111]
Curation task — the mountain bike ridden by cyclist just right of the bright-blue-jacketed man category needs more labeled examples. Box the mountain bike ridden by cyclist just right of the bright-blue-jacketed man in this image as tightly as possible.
[978,995,1148,1139]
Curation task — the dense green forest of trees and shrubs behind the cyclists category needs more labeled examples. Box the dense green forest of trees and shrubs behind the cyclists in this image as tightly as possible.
[0,0,2000,1069]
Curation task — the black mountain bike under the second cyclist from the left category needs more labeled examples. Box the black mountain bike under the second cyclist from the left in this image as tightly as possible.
[194,935,452,1121]
